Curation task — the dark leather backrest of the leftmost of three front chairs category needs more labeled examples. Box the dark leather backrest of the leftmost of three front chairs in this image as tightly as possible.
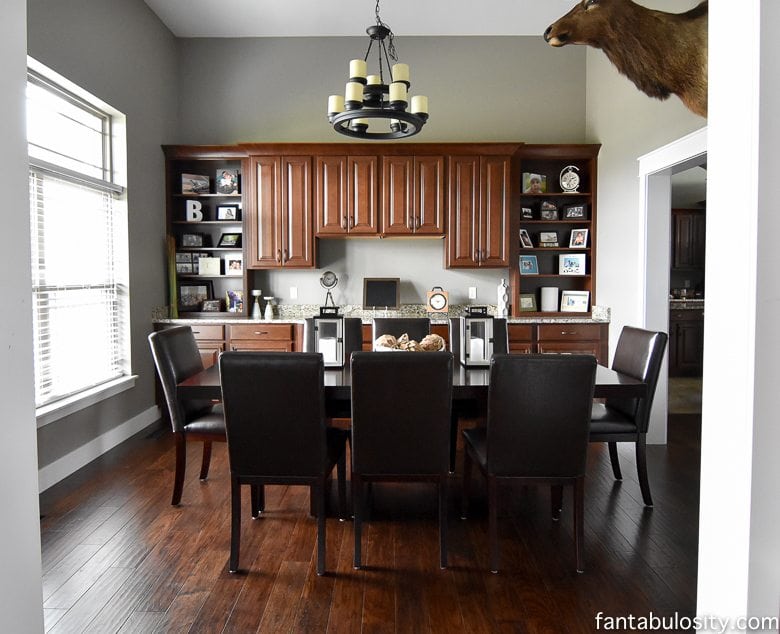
[219,351,326,476]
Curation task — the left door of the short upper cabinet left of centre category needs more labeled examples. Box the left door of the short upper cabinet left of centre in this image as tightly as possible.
[314,156,348,236]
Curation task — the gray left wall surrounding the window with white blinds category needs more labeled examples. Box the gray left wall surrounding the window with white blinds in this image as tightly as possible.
[27,0,176,466]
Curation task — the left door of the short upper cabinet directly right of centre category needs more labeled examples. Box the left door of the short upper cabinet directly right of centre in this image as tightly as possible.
[382,156,415,235]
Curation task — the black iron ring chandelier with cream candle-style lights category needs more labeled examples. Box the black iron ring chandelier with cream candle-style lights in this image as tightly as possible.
[328,0,428,140]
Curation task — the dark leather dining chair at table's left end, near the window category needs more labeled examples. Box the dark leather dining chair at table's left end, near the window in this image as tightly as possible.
[149,326,225,506]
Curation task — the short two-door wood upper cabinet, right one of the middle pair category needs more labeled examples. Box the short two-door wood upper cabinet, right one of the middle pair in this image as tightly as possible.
[382,156,445,236]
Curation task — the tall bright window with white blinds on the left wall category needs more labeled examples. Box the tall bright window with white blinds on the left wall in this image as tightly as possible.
[27,66,129,407]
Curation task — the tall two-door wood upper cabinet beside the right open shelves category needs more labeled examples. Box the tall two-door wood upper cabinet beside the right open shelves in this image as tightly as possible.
[446,156,511,268]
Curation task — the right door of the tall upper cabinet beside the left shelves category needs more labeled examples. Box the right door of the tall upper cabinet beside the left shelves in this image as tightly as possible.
[281,156,314,268]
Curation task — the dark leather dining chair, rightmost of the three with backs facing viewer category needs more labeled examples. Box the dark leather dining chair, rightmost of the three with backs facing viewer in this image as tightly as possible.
[461,354,596,572]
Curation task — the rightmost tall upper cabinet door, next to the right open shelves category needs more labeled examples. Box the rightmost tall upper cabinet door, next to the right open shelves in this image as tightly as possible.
[479,156,510,267]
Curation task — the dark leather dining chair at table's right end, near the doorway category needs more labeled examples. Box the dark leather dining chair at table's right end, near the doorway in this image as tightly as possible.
[590,326,668,506]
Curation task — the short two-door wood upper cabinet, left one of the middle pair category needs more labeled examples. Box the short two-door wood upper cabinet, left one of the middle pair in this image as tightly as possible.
[314,155,379,237]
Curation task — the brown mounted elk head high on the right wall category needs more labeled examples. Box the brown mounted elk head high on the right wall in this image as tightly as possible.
[544,0,707,117]
